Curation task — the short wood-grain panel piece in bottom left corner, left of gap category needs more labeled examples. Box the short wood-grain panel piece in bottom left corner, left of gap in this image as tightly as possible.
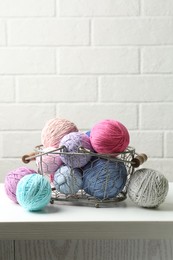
[0,240,15,260]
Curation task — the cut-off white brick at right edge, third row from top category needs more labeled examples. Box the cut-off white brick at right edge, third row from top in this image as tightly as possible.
[141,47,173,73]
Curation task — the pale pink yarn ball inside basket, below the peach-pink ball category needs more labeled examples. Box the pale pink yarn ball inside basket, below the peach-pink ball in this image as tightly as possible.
[36,147,62,174]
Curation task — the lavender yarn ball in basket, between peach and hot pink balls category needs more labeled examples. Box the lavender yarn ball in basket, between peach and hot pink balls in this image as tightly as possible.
[60,132,93,168]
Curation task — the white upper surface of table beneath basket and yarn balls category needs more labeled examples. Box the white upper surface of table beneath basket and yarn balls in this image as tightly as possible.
[0,183,173,223]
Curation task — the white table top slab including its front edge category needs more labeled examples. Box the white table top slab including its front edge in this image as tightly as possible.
[0,183,173,239]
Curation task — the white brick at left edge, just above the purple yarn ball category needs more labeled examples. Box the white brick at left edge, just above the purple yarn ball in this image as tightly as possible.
[0,158,37,183]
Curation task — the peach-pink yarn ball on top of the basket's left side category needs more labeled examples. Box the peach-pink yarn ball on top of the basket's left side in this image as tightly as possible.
[41,118,78,147]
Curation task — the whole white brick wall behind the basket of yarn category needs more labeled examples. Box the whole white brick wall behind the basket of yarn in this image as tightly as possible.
[0,0,173,181]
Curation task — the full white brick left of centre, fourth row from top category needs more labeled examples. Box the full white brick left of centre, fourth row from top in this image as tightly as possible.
[16,77,97,102]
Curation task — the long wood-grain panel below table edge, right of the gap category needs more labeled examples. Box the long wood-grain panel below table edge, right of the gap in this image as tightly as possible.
[15,239,173,260]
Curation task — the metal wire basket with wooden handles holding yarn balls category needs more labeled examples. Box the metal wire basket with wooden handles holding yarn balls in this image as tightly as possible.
[22,145,147,207]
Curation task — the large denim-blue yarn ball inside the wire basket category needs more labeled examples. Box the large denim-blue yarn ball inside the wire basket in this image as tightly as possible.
[83,159,127,199]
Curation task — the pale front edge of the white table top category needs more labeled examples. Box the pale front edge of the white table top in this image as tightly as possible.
[0,221,173,240]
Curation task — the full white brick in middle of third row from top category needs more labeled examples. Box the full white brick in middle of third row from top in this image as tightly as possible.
[59,47,139,74]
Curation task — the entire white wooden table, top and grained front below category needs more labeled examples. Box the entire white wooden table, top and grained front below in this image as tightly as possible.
[0,183,173,260]
